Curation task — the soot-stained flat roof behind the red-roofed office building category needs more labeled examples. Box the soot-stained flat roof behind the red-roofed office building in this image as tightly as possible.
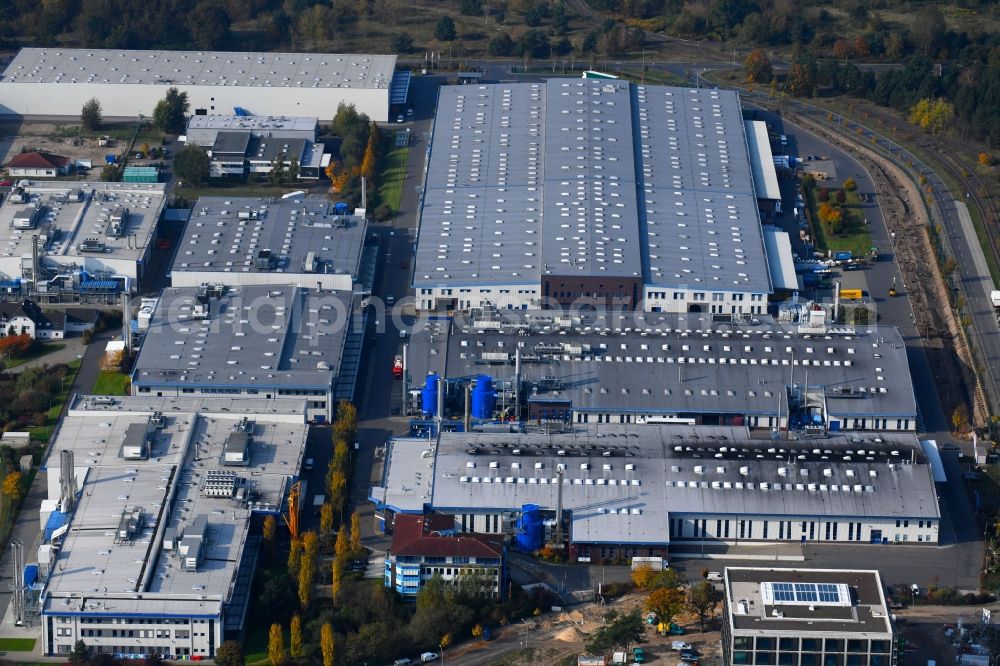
[371,424,940,543]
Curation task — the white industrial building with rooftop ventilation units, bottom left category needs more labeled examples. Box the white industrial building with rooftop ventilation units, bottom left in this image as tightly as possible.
[27,396,308,660]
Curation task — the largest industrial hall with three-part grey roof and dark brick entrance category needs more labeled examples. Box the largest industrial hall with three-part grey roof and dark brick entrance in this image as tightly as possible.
[413,79,792,315]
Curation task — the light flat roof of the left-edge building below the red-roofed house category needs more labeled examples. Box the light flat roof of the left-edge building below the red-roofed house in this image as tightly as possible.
[0,181,166,265]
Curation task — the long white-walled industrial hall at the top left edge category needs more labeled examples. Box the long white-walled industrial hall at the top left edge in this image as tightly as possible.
[0,48,398,122]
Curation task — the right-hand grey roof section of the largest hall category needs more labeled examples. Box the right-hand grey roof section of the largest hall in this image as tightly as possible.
[635,86,770,293]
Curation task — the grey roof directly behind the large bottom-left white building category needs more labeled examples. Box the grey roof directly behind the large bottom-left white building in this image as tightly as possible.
[132,285,352,391]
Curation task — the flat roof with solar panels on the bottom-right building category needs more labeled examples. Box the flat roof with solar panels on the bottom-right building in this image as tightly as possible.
[725,567,892,632]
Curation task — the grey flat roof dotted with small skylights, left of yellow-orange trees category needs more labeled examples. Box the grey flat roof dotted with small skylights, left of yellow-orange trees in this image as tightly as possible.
[171,196,367,282]
